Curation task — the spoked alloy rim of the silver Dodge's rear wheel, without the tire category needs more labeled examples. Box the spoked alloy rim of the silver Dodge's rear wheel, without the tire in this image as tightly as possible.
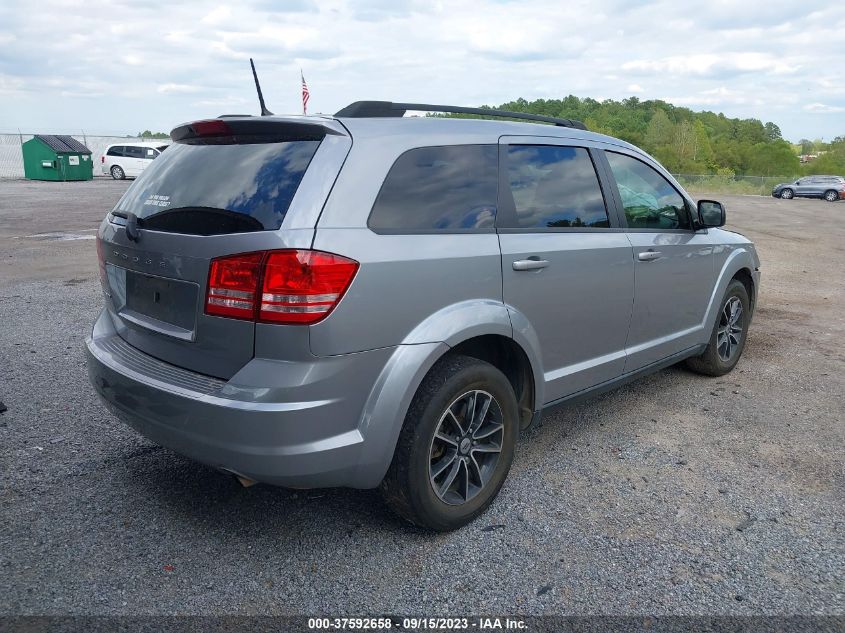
[429,390,505,505]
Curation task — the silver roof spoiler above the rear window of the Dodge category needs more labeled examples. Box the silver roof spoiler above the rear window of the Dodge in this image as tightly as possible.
[170,115,344,144]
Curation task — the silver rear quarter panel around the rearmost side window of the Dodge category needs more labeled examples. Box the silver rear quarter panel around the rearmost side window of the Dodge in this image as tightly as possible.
[310,120,510,356]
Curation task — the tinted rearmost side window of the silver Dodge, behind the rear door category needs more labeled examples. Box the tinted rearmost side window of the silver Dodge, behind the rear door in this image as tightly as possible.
[368,145,498,231]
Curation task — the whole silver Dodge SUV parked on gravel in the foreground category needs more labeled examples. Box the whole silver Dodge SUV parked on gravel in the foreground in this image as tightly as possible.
[86,102,760,530]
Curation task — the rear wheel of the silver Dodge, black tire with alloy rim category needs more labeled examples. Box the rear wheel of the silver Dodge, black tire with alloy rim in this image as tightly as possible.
[381,356,519,532]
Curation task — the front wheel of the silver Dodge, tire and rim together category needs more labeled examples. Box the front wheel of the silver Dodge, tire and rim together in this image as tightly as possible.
[686,279,751,376]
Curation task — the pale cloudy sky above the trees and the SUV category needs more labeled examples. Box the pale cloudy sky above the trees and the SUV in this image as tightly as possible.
[0,0,845,141]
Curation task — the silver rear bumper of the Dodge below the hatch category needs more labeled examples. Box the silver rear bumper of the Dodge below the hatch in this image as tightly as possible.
[86,312,393,488]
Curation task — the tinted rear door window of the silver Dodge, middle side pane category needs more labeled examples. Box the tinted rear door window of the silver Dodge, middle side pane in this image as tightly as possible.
[508,145,610,228]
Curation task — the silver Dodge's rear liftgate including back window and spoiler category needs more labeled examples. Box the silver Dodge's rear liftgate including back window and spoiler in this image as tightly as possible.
[98,117,351,379]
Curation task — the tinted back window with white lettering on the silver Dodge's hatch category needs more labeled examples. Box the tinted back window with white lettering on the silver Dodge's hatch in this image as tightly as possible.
[115,141,320,235]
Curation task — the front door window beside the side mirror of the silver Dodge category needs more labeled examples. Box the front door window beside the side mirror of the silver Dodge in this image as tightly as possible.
[605,152,692,230]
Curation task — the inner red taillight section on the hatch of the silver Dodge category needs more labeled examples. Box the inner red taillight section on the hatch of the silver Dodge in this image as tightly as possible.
[205,253,264,319]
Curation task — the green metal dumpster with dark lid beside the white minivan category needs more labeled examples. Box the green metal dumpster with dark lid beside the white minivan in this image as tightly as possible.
[22,134,94,180]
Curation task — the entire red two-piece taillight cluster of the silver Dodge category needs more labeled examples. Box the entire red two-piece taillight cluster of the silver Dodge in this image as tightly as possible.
[205,249,358,324]
